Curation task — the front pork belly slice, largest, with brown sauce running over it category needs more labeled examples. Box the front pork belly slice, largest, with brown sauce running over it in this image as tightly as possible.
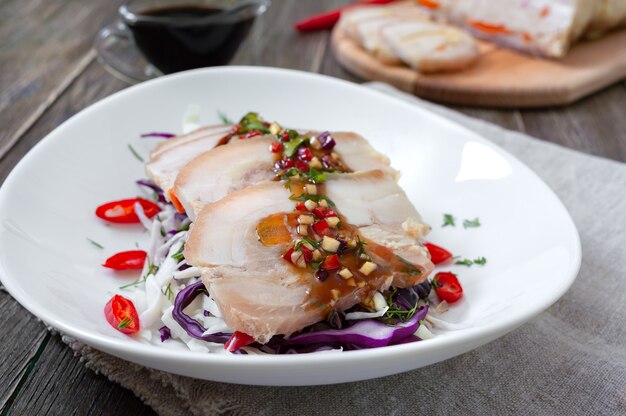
[184,171,433,342]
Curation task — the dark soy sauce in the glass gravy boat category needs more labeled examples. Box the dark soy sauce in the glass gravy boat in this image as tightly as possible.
[128,5,254,74]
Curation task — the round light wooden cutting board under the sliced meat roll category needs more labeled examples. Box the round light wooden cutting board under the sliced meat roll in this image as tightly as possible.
[331,27,626,108]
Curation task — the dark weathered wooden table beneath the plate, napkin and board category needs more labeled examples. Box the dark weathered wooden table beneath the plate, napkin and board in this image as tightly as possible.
[0,0,626,415]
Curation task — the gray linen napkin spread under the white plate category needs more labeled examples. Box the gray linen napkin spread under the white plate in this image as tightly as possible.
[61,84,626,416]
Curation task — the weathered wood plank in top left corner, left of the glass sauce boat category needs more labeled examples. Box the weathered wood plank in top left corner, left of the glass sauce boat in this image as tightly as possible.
[0,0,122,156]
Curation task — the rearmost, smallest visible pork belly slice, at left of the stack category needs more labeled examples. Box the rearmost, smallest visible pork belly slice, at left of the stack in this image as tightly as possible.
[146,125,232,198]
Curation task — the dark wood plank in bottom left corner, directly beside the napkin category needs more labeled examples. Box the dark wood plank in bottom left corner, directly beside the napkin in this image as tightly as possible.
[7,335,155,415]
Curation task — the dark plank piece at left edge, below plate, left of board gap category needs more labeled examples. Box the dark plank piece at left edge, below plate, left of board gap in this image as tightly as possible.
[0,291,47,409]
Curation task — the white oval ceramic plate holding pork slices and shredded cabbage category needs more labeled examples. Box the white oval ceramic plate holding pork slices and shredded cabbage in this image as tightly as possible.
[0,67,580,385]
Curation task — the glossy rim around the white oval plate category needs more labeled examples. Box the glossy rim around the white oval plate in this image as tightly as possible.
[0,66,582,371]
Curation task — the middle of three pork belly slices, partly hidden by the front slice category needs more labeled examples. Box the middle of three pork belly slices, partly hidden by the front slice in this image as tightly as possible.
[174,132,390,219]
